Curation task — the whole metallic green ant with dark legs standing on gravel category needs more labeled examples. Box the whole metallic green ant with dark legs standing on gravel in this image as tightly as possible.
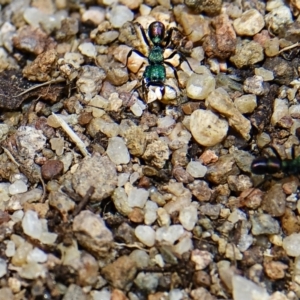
[126,21,197,100]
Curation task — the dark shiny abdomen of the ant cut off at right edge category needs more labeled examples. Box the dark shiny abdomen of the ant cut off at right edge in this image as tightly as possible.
[251,157,282,175]
